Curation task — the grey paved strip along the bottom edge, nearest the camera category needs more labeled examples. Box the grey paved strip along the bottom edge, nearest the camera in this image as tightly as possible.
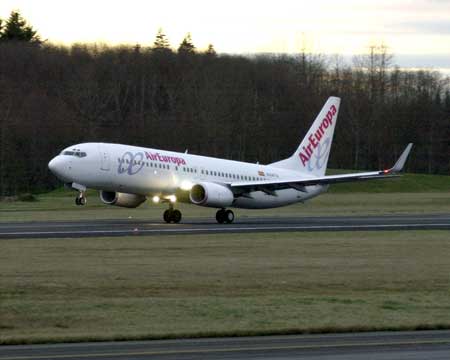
[0,331,450,360]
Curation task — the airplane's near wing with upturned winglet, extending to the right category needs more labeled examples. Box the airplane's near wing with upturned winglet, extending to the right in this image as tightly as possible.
[230,143,413,195]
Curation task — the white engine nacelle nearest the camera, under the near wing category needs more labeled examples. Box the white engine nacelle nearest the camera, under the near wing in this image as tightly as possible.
[189,182,234,208]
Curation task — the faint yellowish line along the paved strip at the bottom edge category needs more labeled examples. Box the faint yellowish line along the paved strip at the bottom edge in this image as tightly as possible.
[0,339,450,360]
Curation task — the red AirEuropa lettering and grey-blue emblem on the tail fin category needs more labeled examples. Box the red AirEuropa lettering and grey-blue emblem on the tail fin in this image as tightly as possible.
[298,105,337,171]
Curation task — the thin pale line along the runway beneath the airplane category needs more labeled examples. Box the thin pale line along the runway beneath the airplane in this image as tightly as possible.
[0,223,450,236]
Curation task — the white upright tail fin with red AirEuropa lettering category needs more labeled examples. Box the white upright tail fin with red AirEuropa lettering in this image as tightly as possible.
[270,97,341,176]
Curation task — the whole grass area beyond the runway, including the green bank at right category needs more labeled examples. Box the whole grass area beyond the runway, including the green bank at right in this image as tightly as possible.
[0,171,450,222]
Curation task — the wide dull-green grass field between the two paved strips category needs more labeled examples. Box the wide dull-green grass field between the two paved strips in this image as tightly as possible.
[0,231,450,343]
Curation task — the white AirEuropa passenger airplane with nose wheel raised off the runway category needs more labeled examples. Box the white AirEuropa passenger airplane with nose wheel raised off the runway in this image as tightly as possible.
[48,97,413,224]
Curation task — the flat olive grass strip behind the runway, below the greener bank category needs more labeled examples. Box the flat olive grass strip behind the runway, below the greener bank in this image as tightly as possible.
[0,192,450,222]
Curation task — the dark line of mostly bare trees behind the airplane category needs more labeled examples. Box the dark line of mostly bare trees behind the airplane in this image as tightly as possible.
[0,14,450,195]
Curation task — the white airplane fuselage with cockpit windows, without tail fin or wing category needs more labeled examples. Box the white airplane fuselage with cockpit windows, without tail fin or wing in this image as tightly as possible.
[49,143,328,209]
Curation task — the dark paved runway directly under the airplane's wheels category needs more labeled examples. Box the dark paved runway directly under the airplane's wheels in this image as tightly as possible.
[0,214,450,239]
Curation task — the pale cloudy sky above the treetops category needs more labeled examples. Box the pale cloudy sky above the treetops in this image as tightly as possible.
[0,0,450,73]
